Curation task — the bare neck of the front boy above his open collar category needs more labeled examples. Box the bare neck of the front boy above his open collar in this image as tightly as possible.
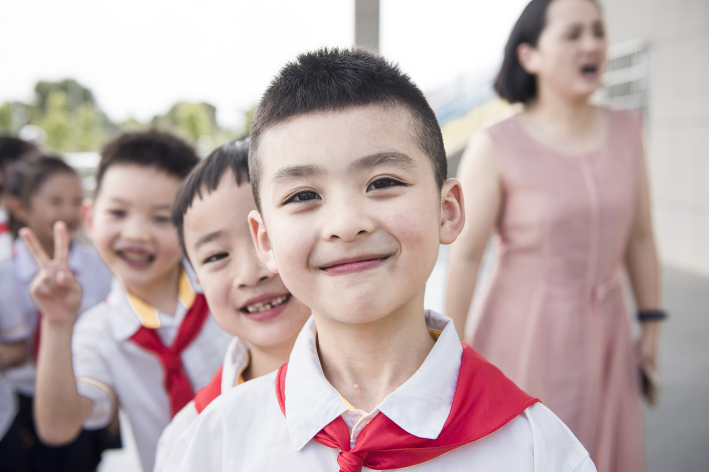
[315,291,435,412]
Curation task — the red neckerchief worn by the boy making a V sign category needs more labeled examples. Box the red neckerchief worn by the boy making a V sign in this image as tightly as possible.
[130,294,209,417]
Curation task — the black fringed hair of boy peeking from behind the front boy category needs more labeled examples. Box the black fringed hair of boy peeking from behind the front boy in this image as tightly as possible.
[172,138,249,256]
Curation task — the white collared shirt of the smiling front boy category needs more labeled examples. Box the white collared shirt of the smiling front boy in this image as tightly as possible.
[165,311,595,471]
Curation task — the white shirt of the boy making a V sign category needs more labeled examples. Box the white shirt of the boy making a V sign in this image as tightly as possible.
[72,268,232,471]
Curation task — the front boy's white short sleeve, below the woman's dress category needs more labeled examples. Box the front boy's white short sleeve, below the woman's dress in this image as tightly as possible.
[524,404,596,471]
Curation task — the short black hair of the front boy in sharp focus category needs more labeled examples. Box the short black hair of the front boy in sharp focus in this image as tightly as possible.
[249,48,448,210]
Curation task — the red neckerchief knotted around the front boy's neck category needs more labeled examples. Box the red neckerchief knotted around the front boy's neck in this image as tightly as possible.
[276,343,539,472]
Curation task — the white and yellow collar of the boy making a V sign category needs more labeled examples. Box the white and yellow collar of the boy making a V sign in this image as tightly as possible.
[106,264,202,342]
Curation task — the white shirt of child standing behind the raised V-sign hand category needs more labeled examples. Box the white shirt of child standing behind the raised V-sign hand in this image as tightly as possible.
[0,238,113,397]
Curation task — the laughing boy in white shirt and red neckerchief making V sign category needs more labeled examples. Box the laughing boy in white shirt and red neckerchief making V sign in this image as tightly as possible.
[20,130,230,470]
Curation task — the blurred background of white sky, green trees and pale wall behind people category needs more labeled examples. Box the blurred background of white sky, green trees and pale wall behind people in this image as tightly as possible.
[0,0,709,471]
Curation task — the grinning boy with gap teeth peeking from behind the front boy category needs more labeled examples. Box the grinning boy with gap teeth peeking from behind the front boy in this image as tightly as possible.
[155,139,310,471]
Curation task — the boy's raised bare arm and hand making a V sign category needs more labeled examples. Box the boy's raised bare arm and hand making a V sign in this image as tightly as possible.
[20,222,93,445]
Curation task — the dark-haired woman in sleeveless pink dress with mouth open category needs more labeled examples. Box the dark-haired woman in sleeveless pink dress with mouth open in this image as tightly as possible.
[446,0,664,471]
